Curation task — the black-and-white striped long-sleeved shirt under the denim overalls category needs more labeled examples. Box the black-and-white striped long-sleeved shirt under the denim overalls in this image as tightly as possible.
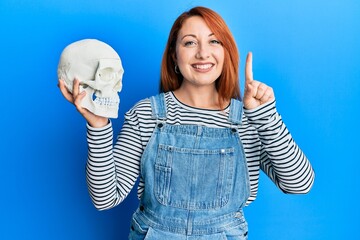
[86,92,314,210]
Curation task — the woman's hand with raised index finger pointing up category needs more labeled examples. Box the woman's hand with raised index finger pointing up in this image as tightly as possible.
[243,52,275,109]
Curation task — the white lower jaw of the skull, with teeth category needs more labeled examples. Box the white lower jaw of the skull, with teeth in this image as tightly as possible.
[81,89,120,118]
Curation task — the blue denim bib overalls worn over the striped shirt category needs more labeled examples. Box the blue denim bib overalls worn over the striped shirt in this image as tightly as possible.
[129,94,250,240]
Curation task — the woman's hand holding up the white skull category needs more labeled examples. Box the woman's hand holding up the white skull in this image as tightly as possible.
[58,79,109,128]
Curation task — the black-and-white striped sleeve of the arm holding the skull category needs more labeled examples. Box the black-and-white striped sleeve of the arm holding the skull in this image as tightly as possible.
[86,118,142,210]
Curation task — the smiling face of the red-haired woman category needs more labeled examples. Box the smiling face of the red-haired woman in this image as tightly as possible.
[174,16,224,87]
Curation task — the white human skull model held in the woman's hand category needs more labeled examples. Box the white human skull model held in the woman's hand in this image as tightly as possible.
[57,39,124,118]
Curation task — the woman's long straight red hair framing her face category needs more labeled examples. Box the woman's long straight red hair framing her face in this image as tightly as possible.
[160,7,241,108]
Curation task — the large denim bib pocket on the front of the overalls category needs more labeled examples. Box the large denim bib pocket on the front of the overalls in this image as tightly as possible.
[154,145,234,210]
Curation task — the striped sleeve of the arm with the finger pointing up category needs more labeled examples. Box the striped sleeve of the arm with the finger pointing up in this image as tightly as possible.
[244,101,315,194]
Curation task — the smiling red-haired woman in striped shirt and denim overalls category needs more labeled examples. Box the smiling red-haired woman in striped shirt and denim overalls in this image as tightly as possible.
[59,7,314,240]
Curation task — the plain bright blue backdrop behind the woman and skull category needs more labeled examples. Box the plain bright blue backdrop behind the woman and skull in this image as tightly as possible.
[0,0,360,240]
